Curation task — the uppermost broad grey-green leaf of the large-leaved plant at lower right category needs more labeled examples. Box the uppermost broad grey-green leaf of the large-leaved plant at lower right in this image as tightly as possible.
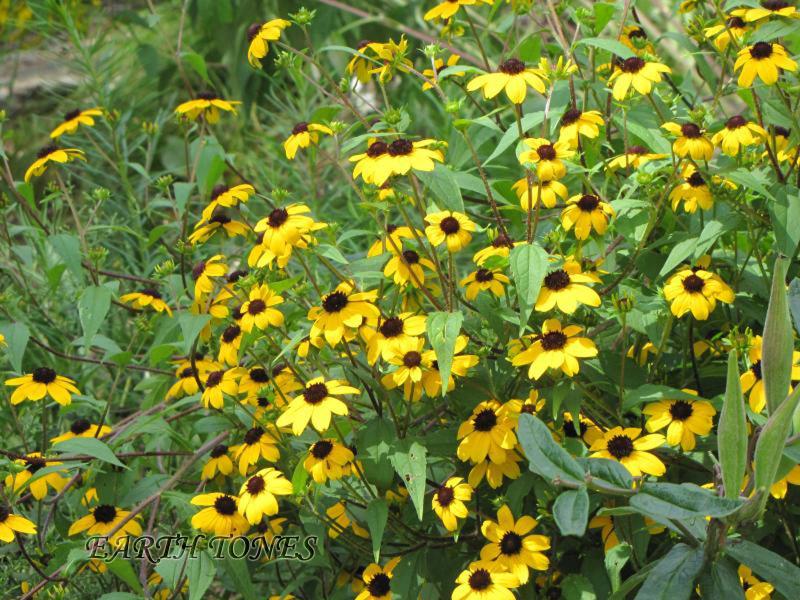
[517,414,586,485]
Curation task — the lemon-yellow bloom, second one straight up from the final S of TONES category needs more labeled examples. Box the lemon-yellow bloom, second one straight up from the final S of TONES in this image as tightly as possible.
[276,377,359,435]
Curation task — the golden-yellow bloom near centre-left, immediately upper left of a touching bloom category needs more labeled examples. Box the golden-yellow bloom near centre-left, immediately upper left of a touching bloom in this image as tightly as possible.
[308,283,380,346]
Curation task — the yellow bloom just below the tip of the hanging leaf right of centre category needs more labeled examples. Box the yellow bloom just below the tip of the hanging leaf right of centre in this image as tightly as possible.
[511,319,597,379]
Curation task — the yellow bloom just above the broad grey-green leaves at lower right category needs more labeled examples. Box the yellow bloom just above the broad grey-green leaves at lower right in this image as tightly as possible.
[589,427,666,477]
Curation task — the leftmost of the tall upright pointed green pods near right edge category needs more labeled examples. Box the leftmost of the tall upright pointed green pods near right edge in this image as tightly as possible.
[717,350,747,498]
